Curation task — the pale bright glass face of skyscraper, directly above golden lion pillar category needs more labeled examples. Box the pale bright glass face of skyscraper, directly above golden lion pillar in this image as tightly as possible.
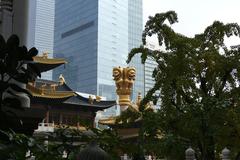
[97,0,128,99]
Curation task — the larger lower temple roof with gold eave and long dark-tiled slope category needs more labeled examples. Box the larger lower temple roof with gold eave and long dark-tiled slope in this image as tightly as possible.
[27,79,116,111]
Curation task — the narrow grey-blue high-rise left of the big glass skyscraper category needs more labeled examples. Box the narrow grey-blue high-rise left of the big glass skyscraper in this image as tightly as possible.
[27,0,55,80]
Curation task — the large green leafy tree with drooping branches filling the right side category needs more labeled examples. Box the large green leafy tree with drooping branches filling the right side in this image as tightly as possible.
[127,11,240,159]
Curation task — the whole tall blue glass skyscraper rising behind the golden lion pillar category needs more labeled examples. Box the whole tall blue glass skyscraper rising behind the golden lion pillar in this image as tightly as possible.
[53,0,143,99]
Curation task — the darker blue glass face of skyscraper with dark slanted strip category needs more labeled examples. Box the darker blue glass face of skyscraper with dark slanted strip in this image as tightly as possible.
[53,0,98,94]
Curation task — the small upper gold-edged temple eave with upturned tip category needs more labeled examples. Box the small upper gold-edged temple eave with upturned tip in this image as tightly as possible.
[33,55,67,72]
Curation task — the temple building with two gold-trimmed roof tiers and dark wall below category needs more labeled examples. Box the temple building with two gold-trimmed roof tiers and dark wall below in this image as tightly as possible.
[30,54,116,132]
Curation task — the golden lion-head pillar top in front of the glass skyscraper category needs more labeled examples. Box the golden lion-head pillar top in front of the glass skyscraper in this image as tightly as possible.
[113,67,136,107]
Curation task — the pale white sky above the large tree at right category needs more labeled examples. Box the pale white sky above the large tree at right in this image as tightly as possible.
[143,0,240,45]
